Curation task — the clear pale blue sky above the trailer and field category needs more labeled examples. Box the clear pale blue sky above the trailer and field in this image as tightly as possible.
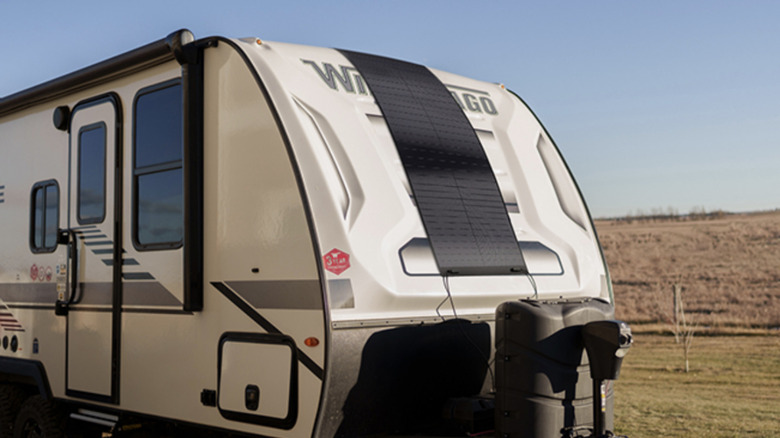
[0,0,780,217]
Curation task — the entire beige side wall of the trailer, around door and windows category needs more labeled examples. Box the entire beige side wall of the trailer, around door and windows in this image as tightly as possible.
[0,44,328,437]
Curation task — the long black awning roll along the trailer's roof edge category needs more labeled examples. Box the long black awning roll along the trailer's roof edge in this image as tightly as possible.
[0,29,195,117]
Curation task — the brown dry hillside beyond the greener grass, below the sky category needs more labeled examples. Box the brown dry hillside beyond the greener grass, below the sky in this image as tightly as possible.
[596,211,780,330]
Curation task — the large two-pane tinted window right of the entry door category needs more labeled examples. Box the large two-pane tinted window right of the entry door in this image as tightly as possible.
[133,81,184,250]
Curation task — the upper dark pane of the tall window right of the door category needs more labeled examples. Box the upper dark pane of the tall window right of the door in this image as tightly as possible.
[135,85,182,167]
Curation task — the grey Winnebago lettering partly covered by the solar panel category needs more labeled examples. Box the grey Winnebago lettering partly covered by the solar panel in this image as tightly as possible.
[301,59,498,116]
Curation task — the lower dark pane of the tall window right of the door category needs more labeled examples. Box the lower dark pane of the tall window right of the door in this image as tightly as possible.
[138,168,184,245]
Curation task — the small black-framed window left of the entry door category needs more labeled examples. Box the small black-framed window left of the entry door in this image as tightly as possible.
[30,180,60,253]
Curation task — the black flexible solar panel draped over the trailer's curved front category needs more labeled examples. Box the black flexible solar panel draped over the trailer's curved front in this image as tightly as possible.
[341,50,527,275]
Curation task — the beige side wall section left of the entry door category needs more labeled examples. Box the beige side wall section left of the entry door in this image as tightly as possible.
[0,105,68,395]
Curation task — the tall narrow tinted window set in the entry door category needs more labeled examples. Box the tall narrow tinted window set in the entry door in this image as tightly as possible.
[78,123,106,224]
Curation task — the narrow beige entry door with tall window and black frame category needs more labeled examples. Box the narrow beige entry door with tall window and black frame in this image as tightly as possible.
[66,95,122,403]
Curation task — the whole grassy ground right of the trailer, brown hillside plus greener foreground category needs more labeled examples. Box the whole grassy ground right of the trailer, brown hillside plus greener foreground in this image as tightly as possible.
[596,212,780,438]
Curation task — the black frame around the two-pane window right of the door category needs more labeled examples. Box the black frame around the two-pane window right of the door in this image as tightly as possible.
[130,78,186,251]
